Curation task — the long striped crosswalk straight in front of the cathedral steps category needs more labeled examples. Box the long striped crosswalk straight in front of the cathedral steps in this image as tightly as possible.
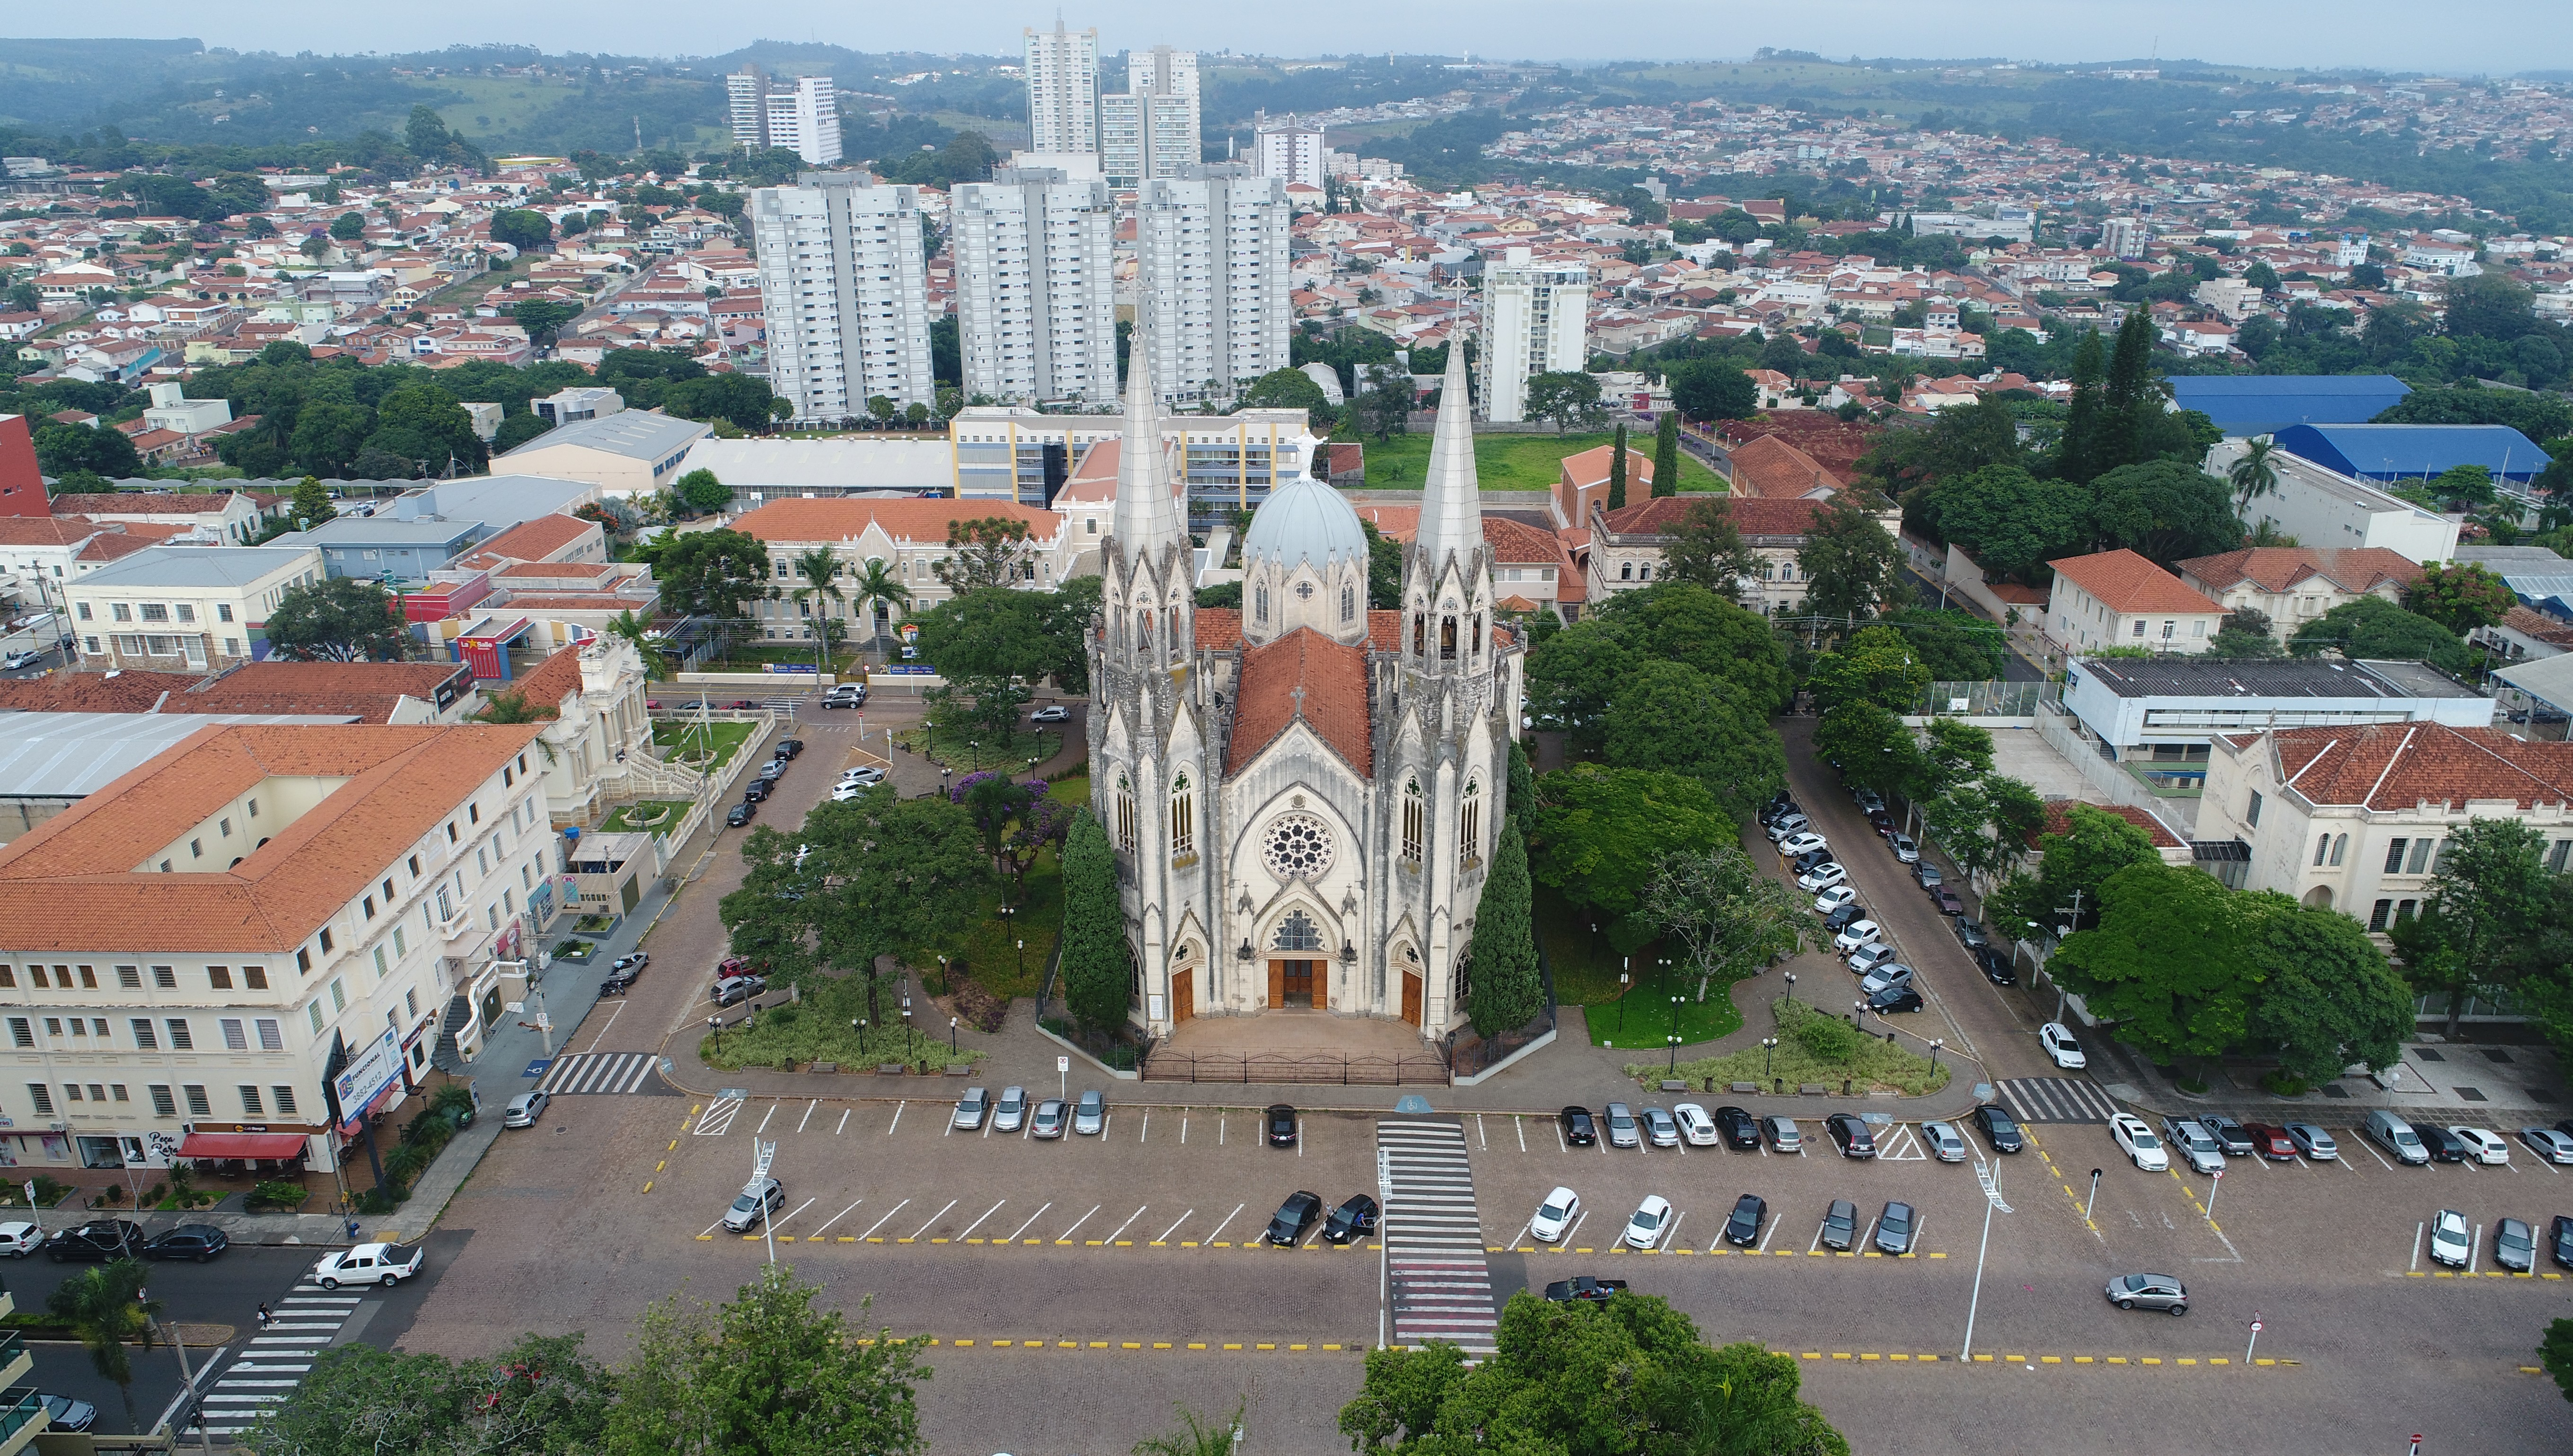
[1376,1119,1500,1353]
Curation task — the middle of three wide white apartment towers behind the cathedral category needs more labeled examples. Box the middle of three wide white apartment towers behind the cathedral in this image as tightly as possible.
[950,167,1117,404]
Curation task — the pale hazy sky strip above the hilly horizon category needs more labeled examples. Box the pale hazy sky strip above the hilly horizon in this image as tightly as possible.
[20,0,2573,75]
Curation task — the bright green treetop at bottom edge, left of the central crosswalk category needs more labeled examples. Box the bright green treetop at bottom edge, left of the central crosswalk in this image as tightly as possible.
[607,1263,929,1456]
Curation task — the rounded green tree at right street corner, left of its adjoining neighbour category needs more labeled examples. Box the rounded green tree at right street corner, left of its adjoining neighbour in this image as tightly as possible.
[2045,857,2259,1068]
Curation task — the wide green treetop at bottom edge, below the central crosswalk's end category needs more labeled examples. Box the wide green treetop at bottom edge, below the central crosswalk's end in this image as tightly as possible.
[1340,1291,1850,1456]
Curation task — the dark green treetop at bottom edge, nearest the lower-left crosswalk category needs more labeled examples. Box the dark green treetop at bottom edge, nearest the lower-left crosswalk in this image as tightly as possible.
[242,1335,615,1456]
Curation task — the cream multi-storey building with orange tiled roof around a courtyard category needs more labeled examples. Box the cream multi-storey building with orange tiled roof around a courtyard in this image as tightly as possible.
[0,726,556,1168]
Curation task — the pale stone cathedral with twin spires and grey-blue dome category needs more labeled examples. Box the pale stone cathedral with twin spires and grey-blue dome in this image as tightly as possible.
[1088,319,1523,1044]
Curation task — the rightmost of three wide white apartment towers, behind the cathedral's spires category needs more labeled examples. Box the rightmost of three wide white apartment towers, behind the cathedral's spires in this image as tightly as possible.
[1135,162,1294,401]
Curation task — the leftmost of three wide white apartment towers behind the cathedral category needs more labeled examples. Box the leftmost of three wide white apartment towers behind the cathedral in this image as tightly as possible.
[751,172,936,419]
